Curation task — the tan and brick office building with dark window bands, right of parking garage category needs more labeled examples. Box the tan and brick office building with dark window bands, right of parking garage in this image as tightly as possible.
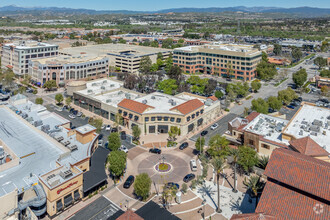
[173,44,261,81]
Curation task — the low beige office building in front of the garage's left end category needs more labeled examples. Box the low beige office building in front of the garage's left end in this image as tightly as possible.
[29,55,109,84]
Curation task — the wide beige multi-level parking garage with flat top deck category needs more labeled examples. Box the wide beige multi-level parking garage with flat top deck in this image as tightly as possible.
[60,44,172,74]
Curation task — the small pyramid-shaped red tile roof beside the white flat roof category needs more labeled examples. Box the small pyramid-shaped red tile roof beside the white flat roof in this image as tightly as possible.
[289,136,329,157]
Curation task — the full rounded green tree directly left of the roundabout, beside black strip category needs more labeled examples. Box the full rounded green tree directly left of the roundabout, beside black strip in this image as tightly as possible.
[108,151,127,177]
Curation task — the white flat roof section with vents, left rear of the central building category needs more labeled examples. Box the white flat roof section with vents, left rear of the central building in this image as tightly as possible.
[77,79,123,96]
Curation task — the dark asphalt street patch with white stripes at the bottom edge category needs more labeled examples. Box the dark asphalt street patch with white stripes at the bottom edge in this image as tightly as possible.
[70,196,124,220]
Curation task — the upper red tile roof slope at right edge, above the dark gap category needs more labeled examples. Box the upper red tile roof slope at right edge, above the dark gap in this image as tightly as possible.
[264,148,330,200]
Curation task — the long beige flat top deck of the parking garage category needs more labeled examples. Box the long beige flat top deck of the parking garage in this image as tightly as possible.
[60,44,172,57]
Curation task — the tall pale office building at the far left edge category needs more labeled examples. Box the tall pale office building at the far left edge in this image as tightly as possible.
[1,41,58,75]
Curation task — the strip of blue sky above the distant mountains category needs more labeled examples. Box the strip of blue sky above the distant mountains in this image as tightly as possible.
[0,0,330,11]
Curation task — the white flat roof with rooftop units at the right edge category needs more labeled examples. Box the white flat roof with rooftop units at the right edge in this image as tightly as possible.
[283,103,330,152]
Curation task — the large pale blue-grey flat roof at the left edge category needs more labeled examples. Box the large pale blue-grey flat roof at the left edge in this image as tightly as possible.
[0,107,65,196]
